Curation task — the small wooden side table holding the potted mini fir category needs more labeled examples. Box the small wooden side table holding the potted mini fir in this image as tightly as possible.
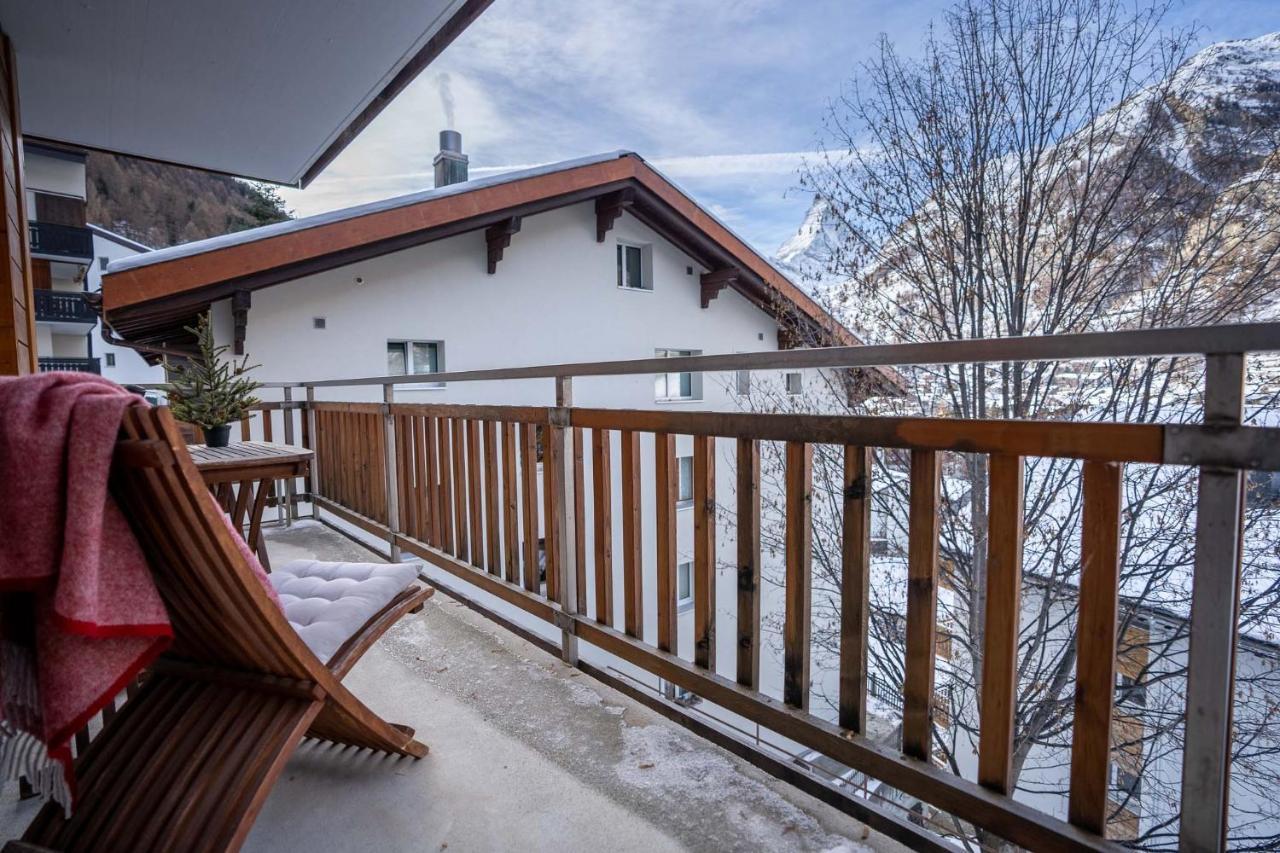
[187,442,315,571]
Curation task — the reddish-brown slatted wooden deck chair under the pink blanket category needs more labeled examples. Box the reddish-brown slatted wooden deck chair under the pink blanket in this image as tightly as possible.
[13,406,434,850]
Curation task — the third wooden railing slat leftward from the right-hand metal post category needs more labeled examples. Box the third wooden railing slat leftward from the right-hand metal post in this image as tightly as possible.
[902,451,941,761]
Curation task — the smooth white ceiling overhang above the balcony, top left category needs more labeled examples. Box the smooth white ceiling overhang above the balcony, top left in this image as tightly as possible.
[0,0,492,184]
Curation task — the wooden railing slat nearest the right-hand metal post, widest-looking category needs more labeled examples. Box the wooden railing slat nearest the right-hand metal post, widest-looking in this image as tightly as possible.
[1068,462,1121,835]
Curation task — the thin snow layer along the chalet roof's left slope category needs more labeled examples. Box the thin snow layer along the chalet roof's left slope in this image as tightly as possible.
[106,150,639,275]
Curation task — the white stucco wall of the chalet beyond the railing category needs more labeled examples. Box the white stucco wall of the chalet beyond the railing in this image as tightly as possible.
[214,202,834,690]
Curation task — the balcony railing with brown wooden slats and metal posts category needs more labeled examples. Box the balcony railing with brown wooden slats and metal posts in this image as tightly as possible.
[225,318,1280,850]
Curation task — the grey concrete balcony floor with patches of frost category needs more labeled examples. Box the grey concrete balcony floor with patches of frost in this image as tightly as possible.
[0,521,901,853]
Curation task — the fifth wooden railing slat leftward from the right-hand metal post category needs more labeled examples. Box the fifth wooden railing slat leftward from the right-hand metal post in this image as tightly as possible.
[782,442,813,711]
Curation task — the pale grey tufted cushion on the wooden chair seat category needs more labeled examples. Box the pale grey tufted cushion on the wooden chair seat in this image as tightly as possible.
[268,560,417,663]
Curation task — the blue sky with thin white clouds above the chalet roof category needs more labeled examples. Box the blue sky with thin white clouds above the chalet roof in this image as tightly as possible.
[283,0,1280,254]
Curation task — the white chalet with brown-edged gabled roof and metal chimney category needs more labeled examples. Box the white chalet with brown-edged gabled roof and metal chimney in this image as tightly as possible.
[104,137,896,671]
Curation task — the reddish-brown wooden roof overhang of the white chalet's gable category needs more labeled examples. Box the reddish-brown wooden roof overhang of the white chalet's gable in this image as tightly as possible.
[101,154,892,384]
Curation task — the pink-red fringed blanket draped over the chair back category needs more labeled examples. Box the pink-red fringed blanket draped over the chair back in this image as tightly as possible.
[0,373,173,808]
